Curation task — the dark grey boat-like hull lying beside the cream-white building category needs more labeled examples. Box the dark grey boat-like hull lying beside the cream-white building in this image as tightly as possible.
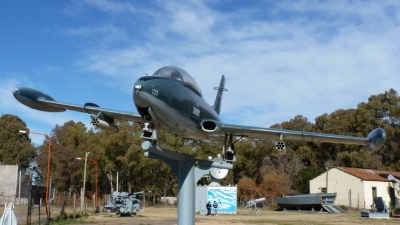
[276,193,343,213]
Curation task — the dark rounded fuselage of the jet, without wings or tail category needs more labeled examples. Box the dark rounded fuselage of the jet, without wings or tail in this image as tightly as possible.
[133,67,221,139]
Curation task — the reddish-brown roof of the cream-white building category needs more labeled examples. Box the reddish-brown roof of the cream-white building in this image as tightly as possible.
[336,166,400,181]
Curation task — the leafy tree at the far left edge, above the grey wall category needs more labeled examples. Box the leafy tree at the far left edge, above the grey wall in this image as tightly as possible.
[0,114,37,170]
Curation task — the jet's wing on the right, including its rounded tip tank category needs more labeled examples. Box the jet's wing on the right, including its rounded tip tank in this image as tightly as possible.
[218,124,386,150]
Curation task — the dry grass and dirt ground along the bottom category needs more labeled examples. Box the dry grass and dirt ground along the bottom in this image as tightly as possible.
[5,206,400,225]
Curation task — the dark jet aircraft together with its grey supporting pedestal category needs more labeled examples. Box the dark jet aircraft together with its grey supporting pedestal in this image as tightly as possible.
[13,66,386,225]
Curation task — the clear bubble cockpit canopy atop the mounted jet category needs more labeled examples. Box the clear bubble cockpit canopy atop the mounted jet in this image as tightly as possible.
[153,66,203,97]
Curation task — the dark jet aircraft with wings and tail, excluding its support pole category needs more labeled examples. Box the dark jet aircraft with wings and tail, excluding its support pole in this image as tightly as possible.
[13,66,386,161]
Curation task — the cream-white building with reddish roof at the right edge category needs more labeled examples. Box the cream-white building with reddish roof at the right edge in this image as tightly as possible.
[310,167,400,209]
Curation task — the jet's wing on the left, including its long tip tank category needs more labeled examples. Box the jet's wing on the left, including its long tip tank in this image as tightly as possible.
[13,87,144,122]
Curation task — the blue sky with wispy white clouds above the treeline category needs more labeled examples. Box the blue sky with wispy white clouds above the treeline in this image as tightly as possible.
[0,0,400,144]
